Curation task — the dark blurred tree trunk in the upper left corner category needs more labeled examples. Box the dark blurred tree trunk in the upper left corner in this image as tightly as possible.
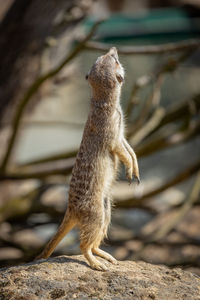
[0,0,92,119]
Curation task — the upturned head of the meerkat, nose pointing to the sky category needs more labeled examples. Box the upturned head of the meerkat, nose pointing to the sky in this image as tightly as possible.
[86,47,124,89]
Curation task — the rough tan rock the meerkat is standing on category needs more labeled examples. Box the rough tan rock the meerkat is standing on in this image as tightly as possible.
[0,256,200,300]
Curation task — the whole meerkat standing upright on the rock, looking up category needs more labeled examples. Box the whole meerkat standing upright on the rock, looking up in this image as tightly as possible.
[37,47,139,271]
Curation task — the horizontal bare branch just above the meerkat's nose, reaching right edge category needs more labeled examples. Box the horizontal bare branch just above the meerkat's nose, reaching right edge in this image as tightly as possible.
[86,39,200,55]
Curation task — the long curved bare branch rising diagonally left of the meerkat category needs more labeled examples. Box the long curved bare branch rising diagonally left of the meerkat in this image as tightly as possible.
[0,21,101,173]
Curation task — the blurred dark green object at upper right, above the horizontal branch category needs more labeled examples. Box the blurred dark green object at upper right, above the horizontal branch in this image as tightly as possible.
[84,8,200,45]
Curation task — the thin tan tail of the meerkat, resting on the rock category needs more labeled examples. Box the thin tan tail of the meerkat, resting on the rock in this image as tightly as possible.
[36,216,75,259]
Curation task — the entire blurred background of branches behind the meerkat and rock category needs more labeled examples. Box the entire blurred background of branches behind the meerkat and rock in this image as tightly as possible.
[0,0,200,275]
